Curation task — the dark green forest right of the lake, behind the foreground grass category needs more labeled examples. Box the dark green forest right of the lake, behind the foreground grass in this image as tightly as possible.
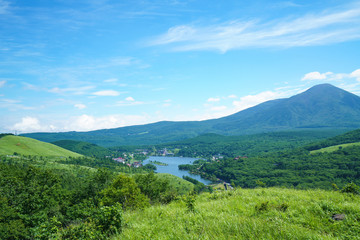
[185,146,360,189]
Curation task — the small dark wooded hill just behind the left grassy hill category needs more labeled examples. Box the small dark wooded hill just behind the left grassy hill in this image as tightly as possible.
[52,140,113,158]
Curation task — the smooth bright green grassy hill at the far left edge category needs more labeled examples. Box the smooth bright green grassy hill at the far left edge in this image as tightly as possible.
[0,135,82,157]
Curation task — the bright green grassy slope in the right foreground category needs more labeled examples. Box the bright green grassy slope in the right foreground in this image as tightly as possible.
[114,188,360,239]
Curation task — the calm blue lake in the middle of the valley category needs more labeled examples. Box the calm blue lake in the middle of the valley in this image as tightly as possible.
[143,156,211,185]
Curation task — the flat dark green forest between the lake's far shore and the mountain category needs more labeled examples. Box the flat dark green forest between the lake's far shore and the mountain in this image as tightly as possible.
[162,130,343,158]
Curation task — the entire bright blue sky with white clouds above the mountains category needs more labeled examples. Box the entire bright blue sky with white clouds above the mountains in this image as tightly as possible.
[0,0,360,133]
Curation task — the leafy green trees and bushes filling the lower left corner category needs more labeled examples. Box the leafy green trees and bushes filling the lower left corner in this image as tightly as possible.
[0,156,194,239]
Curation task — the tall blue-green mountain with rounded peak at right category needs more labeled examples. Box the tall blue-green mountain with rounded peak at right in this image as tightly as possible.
[212,84,360,134]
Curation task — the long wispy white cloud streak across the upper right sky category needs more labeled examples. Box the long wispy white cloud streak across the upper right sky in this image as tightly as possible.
[149,4,360,52]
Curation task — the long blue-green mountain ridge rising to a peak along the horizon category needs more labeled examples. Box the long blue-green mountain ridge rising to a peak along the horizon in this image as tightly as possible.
[24,84,360,146]
